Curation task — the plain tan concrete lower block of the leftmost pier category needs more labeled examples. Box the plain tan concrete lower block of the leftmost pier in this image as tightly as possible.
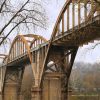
[3,83,18,100]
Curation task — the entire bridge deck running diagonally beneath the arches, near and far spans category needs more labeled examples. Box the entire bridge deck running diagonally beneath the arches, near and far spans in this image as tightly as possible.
[2,15,100,67]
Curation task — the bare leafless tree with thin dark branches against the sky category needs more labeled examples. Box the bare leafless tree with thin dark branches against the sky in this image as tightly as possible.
[0,0,46,45]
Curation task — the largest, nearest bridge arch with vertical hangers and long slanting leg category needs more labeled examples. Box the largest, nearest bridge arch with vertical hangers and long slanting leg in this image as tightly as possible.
[40,0,100,84]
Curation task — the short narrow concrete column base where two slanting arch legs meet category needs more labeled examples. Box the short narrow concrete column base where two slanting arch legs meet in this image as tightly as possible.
[31,87,41,100]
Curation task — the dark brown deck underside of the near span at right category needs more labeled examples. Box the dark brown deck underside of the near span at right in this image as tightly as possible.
[53,15,100,46]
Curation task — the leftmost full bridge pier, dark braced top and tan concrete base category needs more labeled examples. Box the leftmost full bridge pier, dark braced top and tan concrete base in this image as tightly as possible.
[2,66,23,100]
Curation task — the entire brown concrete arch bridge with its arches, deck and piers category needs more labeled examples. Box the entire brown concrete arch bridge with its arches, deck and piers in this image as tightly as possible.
[2,0,100,100]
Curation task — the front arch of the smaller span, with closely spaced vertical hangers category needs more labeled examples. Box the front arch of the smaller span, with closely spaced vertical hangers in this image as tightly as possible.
[7,35,32,62]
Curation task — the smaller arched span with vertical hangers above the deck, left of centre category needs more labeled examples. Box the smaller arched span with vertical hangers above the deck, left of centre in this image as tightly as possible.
[4,34,47,63]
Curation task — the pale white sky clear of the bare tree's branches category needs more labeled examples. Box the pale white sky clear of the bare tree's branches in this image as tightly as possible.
[0,0,100,63]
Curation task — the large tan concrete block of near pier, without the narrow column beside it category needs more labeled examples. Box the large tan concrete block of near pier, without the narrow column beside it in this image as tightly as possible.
[42,73,67,100]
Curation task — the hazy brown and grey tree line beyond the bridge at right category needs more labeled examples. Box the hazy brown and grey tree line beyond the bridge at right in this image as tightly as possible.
[69,62,100,92]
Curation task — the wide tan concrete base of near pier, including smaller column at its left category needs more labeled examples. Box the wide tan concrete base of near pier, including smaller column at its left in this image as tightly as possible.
[31,72,68,100]
